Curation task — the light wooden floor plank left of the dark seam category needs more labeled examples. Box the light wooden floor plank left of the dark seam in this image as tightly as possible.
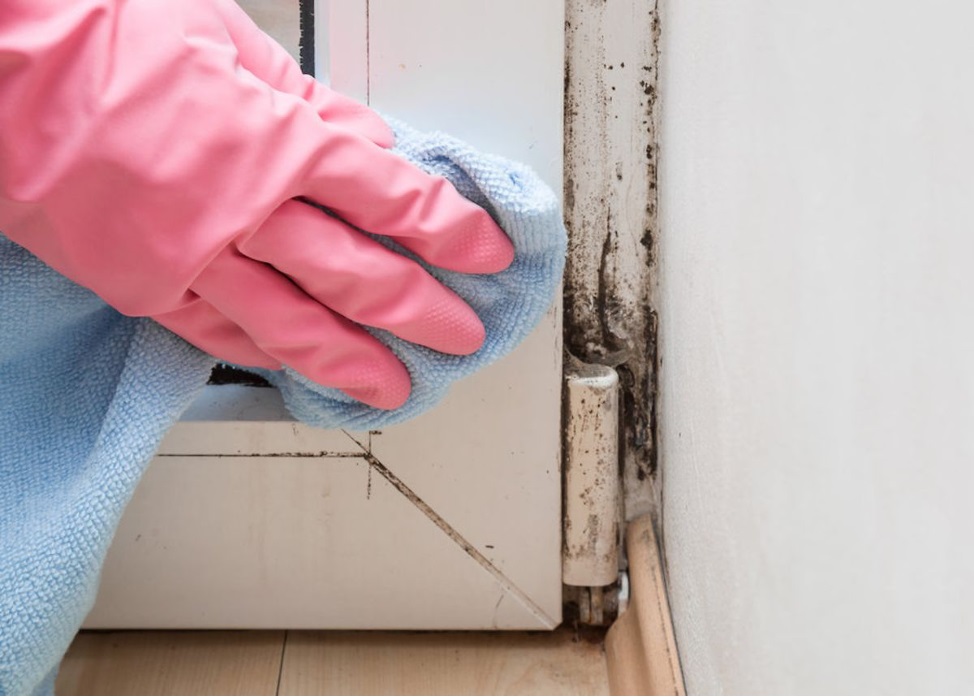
[56,631,285,695]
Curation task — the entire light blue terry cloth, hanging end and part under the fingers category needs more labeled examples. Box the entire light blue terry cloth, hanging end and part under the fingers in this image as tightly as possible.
[0,117,566,694]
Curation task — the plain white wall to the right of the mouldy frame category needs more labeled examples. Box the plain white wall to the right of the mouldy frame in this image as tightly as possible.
[659,0,974,693]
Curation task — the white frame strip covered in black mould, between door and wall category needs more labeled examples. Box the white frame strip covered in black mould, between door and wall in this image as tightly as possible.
[564,0,660,518]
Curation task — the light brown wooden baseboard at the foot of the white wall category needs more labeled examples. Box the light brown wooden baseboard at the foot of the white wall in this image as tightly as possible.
[605,516,686,695]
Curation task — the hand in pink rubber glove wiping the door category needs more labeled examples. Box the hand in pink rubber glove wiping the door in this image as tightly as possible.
[0,0,513,408]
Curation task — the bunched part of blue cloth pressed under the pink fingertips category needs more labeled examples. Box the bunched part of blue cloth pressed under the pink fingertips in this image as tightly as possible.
[266,119,567,430]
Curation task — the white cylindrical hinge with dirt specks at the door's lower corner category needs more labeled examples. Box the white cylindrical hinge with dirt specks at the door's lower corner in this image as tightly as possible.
[562,358,625,625]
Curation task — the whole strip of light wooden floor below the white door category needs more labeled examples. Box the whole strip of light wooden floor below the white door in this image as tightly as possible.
[57,629,609,695]
